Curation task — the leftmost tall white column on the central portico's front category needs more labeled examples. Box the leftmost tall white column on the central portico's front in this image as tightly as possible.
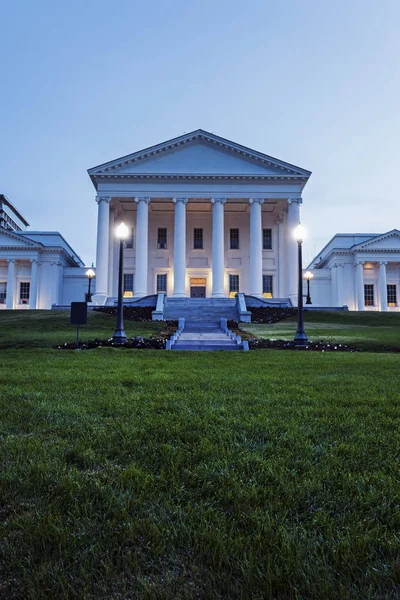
[92,196,111,304]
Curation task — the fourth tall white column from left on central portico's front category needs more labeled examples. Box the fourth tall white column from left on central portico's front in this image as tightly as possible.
[211,197,226,298]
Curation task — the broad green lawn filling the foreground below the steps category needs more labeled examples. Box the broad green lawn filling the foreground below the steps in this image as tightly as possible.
[0,313,400,600]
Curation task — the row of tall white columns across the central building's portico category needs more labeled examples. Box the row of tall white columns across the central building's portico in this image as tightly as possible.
[94,196,302,304]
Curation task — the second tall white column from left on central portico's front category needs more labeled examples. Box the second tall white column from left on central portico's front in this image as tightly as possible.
[134,196,150,298]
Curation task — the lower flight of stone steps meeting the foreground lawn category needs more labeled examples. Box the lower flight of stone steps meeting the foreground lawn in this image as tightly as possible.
[172,322,242,350]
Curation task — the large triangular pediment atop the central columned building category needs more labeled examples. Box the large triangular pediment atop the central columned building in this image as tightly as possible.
[89,130,311,179]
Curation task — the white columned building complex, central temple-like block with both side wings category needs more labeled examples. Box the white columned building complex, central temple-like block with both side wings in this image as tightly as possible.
[0,130,400,310]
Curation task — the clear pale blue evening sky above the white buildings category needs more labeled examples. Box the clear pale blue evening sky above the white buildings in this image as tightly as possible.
[0,0,400,264]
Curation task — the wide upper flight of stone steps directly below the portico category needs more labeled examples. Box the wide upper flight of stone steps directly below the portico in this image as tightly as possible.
[164,298,239,322]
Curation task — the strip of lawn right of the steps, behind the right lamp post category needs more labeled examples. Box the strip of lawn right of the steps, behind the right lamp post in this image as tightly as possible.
[243,311,400,351]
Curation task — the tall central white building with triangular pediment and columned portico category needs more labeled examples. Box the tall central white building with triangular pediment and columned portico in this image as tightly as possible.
[89,130,311,304]
